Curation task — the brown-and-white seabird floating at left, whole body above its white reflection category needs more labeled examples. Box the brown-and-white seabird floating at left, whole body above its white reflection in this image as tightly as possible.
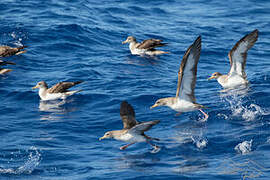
[32,81,82,100]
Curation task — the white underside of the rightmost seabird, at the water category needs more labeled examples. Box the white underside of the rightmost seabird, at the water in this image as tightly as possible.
[217,75,247,88]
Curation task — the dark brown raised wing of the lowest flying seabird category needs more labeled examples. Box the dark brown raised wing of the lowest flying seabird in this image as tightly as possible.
[120,101,138,129]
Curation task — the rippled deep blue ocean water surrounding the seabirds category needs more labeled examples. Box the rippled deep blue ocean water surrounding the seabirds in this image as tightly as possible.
[0,0,270,180]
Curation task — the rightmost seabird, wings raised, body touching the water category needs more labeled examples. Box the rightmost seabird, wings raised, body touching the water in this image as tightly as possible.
[208,29,259,88]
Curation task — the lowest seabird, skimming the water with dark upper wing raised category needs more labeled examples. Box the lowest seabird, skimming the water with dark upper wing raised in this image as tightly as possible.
[99,101,160,150]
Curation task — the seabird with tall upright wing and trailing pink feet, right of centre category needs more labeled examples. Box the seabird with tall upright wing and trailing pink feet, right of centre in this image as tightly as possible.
[151,36,208,120]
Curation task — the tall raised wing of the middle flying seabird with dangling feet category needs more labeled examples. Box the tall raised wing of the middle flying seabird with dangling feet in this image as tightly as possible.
[176,36,201,103]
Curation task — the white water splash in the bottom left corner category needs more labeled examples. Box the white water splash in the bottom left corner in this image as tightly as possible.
[0,146,41,175]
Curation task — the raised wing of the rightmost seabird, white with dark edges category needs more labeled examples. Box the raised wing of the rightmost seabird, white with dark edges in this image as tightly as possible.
[228,29,259,78]
